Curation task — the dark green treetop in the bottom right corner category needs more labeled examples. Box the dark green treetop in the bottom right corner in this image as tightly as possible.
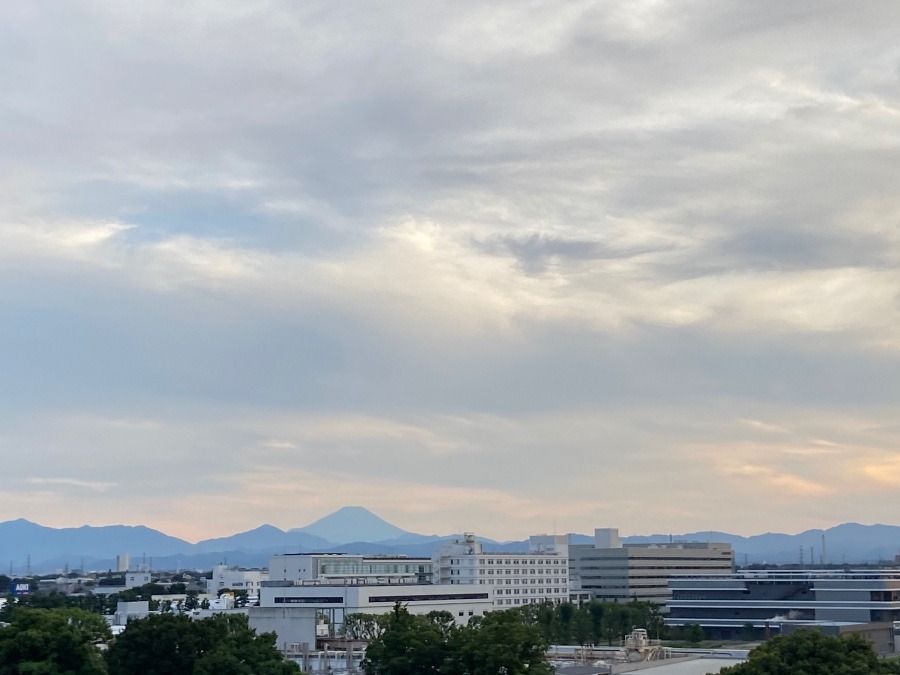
[721,630,900,675]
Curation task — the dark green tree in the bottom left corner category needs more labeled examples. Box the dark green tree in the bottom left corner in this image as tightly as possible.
[0,607,111,675]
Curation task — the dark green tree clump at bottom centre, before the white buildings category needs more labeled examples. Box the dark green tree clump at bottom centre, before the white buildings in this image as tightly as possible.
[363,605,552,675]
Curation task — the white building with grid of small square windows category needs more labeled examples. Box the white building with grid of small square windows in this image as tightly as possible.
[434,532,569,609]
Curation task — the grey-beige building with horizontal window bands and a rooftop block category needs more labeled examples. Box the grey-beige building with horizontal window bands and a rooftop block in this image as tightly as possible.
[568,528,734,604]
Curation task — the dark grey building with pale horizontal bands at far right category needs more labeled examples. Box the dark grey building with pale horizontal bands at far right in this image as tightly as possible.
[666,570,900,637]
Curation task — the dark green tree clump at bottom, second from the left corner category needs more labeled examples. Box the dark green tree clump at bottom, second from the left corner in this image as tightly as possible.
[101,614,300,675]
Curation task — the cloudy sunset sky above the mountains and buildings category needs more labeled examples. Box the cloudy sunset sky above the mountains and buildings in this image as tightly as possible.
[0,0,900,540]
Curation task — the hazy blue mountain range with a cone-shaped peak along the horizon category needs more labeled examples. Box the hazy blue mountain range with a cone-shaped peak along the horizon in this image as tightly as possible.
[0,506,900,574]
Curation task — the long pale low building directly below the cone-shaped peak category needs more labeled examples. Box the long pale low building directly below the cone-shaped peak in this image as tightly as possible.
[269,553,432,584]
